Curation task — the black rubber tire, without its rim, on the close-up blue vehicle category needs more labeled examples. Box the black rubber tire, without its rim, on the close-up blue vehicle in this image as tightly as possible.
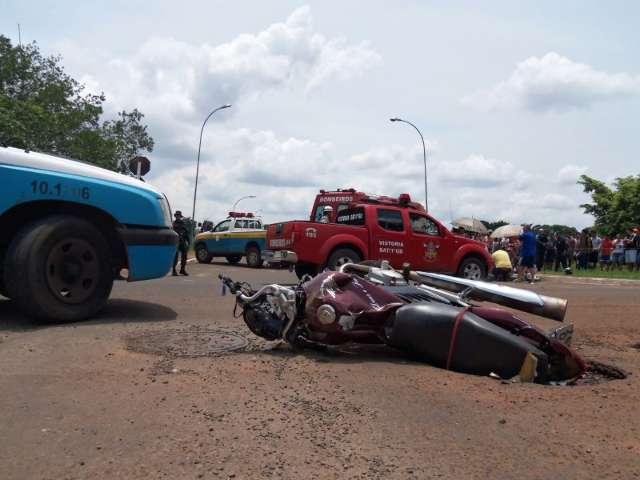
[4,215,114,322]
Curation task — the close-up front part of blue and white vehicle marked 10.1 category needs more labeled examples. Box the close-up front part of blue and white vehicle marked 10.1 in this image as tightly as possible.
[0,146,178,321]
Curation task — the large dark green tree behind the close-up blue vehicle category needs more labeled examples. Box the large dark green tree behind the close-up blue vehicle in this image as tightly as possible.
[0,35,153,170]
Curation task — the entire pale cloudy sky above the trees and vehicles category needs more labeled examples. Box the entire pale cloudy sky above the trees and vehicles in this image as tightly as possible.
[0,0,640,227]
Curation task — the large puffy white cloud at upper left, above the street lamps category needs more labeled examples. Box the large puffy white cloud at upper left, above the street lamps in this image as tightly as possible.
[58,6,381,122]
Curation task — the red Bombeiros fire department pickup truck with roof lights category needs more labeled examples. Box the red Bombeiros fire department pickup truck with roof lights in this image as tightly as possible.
[264,189,492,280]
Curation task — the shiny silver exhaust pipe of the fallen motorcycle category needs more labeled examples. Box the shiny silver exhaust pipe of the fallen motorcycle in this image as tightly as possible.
[411,272,567,322]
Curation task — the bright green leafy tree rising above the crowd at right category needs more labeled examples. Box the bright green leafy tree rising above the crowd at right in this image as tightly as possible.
[578,175,640,235]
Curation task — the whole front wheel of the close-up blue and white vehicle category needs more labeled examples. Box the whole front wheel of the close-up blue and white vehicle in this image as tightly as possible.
[5,215,114,322]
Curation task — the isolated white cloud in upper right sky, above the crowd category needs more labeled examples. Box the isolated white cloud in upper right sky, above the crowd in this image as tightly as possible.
[462,52,640,112]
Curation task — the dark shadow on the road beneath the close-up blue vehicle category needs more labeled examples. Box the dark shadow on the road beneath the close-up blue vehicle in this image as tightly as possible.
[0,297,178,331]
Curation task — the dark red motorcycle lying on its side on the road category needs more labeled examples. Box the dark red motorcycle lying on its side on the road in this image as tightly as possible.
[220,263,586,383]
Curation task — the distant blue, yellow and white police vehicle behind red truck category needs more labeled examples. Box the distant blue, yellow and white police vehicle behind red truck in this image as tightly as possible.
[195,212,267,268]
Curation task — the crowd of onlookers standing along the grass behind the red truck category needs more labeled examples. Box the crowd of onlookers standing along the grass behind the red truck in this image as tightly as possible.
[464,225,640,280]
